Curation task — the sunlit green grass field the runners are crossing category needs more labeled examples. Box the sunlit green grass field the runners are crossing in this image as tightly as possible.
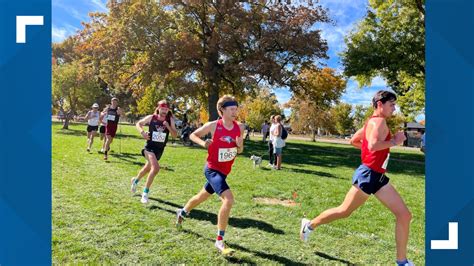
[52,123,425,265]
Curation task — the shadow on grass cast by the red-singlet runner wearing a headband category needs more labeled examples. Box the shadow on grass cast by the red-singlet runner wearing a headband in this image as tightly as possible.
[182,229,305,265]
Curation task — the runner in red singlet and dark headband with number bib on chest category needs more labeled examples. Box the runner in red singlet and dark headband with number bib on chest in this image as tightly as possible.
[176,95,245,255]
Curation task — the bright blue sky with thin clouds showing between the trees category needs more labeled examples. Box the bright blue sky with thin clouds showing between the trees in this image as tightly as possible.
[52,0,422,121]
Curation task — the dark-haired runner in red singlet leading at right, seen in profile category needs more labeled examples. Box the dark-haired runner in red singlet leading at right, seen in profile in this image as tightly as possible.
[300,90,413,265]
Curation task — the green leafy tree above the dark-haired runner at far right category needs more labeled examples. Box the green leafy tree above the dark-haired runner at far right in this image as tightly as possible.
[342,0,425,118]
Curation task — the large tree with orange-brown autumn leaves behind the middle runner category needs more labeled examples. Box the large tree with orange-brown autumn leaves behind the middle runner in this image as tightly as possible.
[79,0,329,119]
